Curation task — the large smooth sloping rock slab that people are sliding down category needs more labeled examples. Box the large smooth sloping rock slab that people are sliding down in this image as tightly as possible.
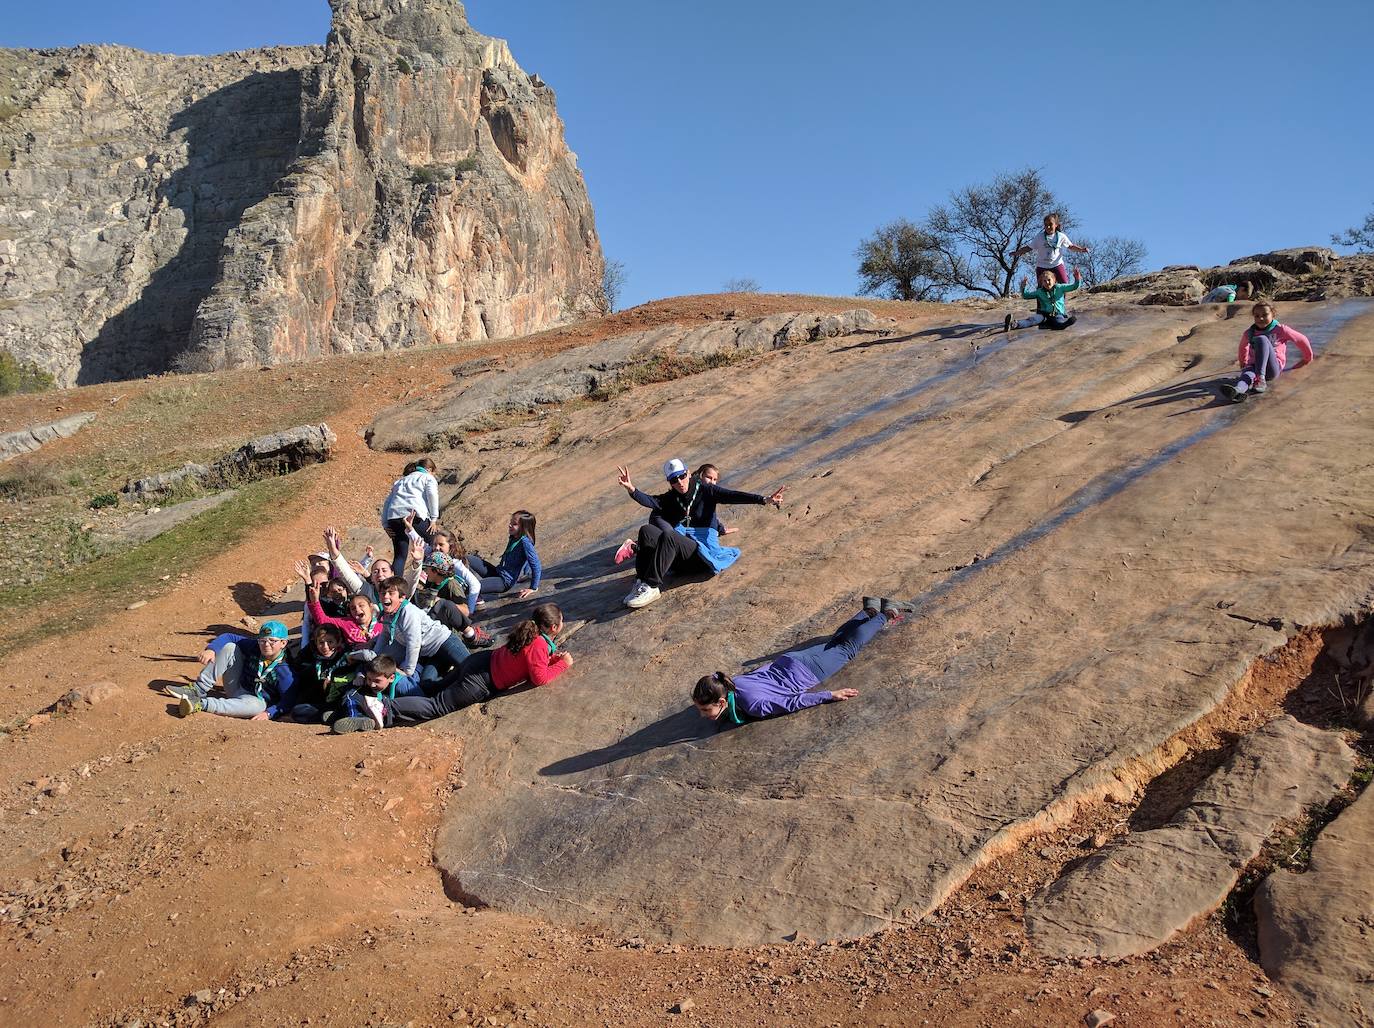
[384,301,1374,943]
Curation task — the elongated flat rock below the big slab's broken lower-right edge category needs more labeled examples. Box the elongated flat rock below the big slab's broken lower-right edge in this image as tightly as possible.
[1026,715,1355,959]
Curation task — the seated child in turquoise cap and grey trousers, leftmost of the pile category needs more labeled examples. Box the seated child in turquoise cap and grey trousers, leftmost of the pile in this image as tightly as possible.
[166,621,295,722]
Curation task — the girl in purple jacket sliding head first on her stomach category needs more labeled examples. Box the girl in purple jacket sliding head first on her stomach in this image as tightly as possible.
[691,596,915,724]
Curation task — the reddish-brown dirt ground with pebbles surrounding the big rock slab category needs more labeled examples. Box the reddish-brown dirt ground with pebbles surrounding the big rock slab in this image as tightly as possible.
[0,297,1338,1025]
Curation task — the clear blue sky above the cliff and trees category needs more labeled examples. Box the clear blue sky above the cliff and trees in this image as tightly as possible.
[0,0,1374,305]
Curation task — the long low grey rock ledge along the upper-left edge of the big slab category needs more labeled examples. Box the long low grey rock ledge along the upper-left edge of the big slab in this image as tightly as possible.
[368,308,890,451]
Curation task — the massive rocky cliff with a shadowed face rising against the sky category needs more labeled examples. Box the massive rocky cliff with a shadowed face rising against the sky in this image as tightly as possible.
[0,0,602,383]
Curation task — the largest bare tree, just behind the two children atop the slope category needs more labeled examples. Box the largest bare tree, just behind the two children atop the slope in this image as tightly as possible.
[923,168,1070,297]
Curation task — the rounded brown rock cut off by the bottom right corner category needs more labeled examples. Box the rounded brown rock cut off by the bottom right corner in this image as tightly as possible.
[1254,789,1374,1025]
